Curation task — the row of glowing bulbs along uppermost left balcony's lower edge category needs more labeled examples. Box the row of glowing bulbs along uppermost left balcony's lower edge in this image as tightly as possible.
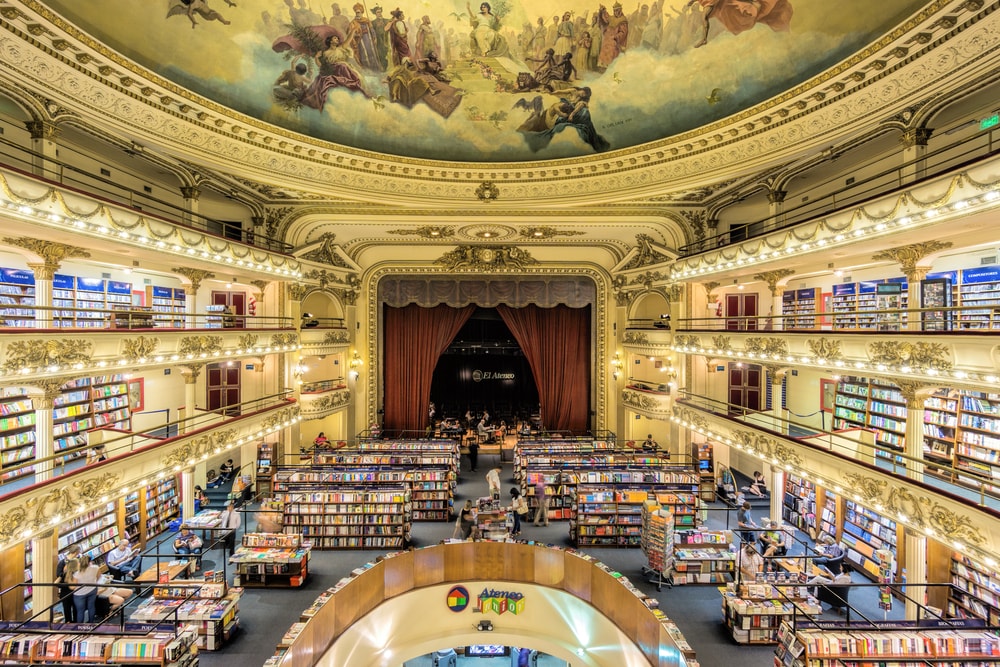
[2,200,302,278]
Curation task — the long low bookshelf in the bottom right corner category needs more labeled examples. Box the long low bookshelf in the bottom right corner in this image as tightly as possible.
[775,621,1000,667]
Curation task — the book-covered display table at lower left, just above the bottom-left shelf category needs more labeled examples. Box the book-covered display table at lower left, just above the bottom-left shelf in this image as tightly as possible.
[130,572,243,651]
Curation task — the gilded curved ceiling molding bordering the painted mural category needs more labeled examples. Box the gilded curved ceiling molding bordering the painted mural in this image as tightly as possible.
[0,0,984,200]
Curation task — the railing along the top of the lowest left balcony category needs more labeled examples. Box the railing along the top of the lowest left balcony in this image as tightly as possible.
[0,391,292,500]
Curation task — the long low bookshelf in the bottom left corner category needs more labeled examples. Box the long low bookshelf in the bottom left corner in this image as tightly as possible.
[0,624,198,667]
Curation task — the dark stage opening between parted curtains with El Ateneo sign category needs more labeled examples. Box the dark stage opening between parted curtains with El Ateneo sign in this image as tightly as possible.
[431,308,538,426]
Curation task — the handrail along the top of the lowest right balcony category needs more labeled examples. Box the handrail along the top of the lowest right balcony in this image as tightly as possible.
[677,389,1000,512]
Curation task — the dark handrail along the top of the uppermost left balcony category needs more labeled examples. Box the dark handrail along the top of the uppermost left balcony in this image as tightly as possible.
[0,130,292,255]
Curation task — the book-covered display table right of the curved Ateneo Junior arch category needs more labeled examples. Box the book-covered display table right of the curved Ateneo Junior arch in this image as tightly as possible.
[722,583,823,644]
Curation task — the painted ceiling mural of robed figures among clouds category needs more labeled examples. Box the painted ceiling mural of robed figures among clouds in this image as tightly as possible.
[43,0,923,162]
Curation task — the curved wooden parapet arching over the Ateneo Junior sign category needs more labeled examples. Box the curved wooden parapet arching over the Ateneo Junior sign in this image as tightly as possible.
[277,542,686,667]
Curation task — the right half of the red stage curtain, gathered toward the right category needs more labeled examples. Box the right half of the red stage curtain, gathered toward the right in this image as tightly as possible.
[496,304,590,433]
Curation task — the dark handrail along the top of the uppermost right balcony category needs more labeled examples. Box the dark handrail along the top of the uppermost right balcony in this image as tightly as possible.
[679,116,1000,258]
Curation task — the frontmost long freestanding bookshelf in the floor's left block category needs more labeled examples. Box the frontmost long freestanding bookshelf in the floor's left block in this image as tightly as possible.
[274,478,410,549]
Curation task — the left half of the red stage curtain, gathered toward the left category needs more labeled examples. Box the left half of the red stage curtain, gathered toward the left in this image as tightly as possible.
[383,305,476,435]
